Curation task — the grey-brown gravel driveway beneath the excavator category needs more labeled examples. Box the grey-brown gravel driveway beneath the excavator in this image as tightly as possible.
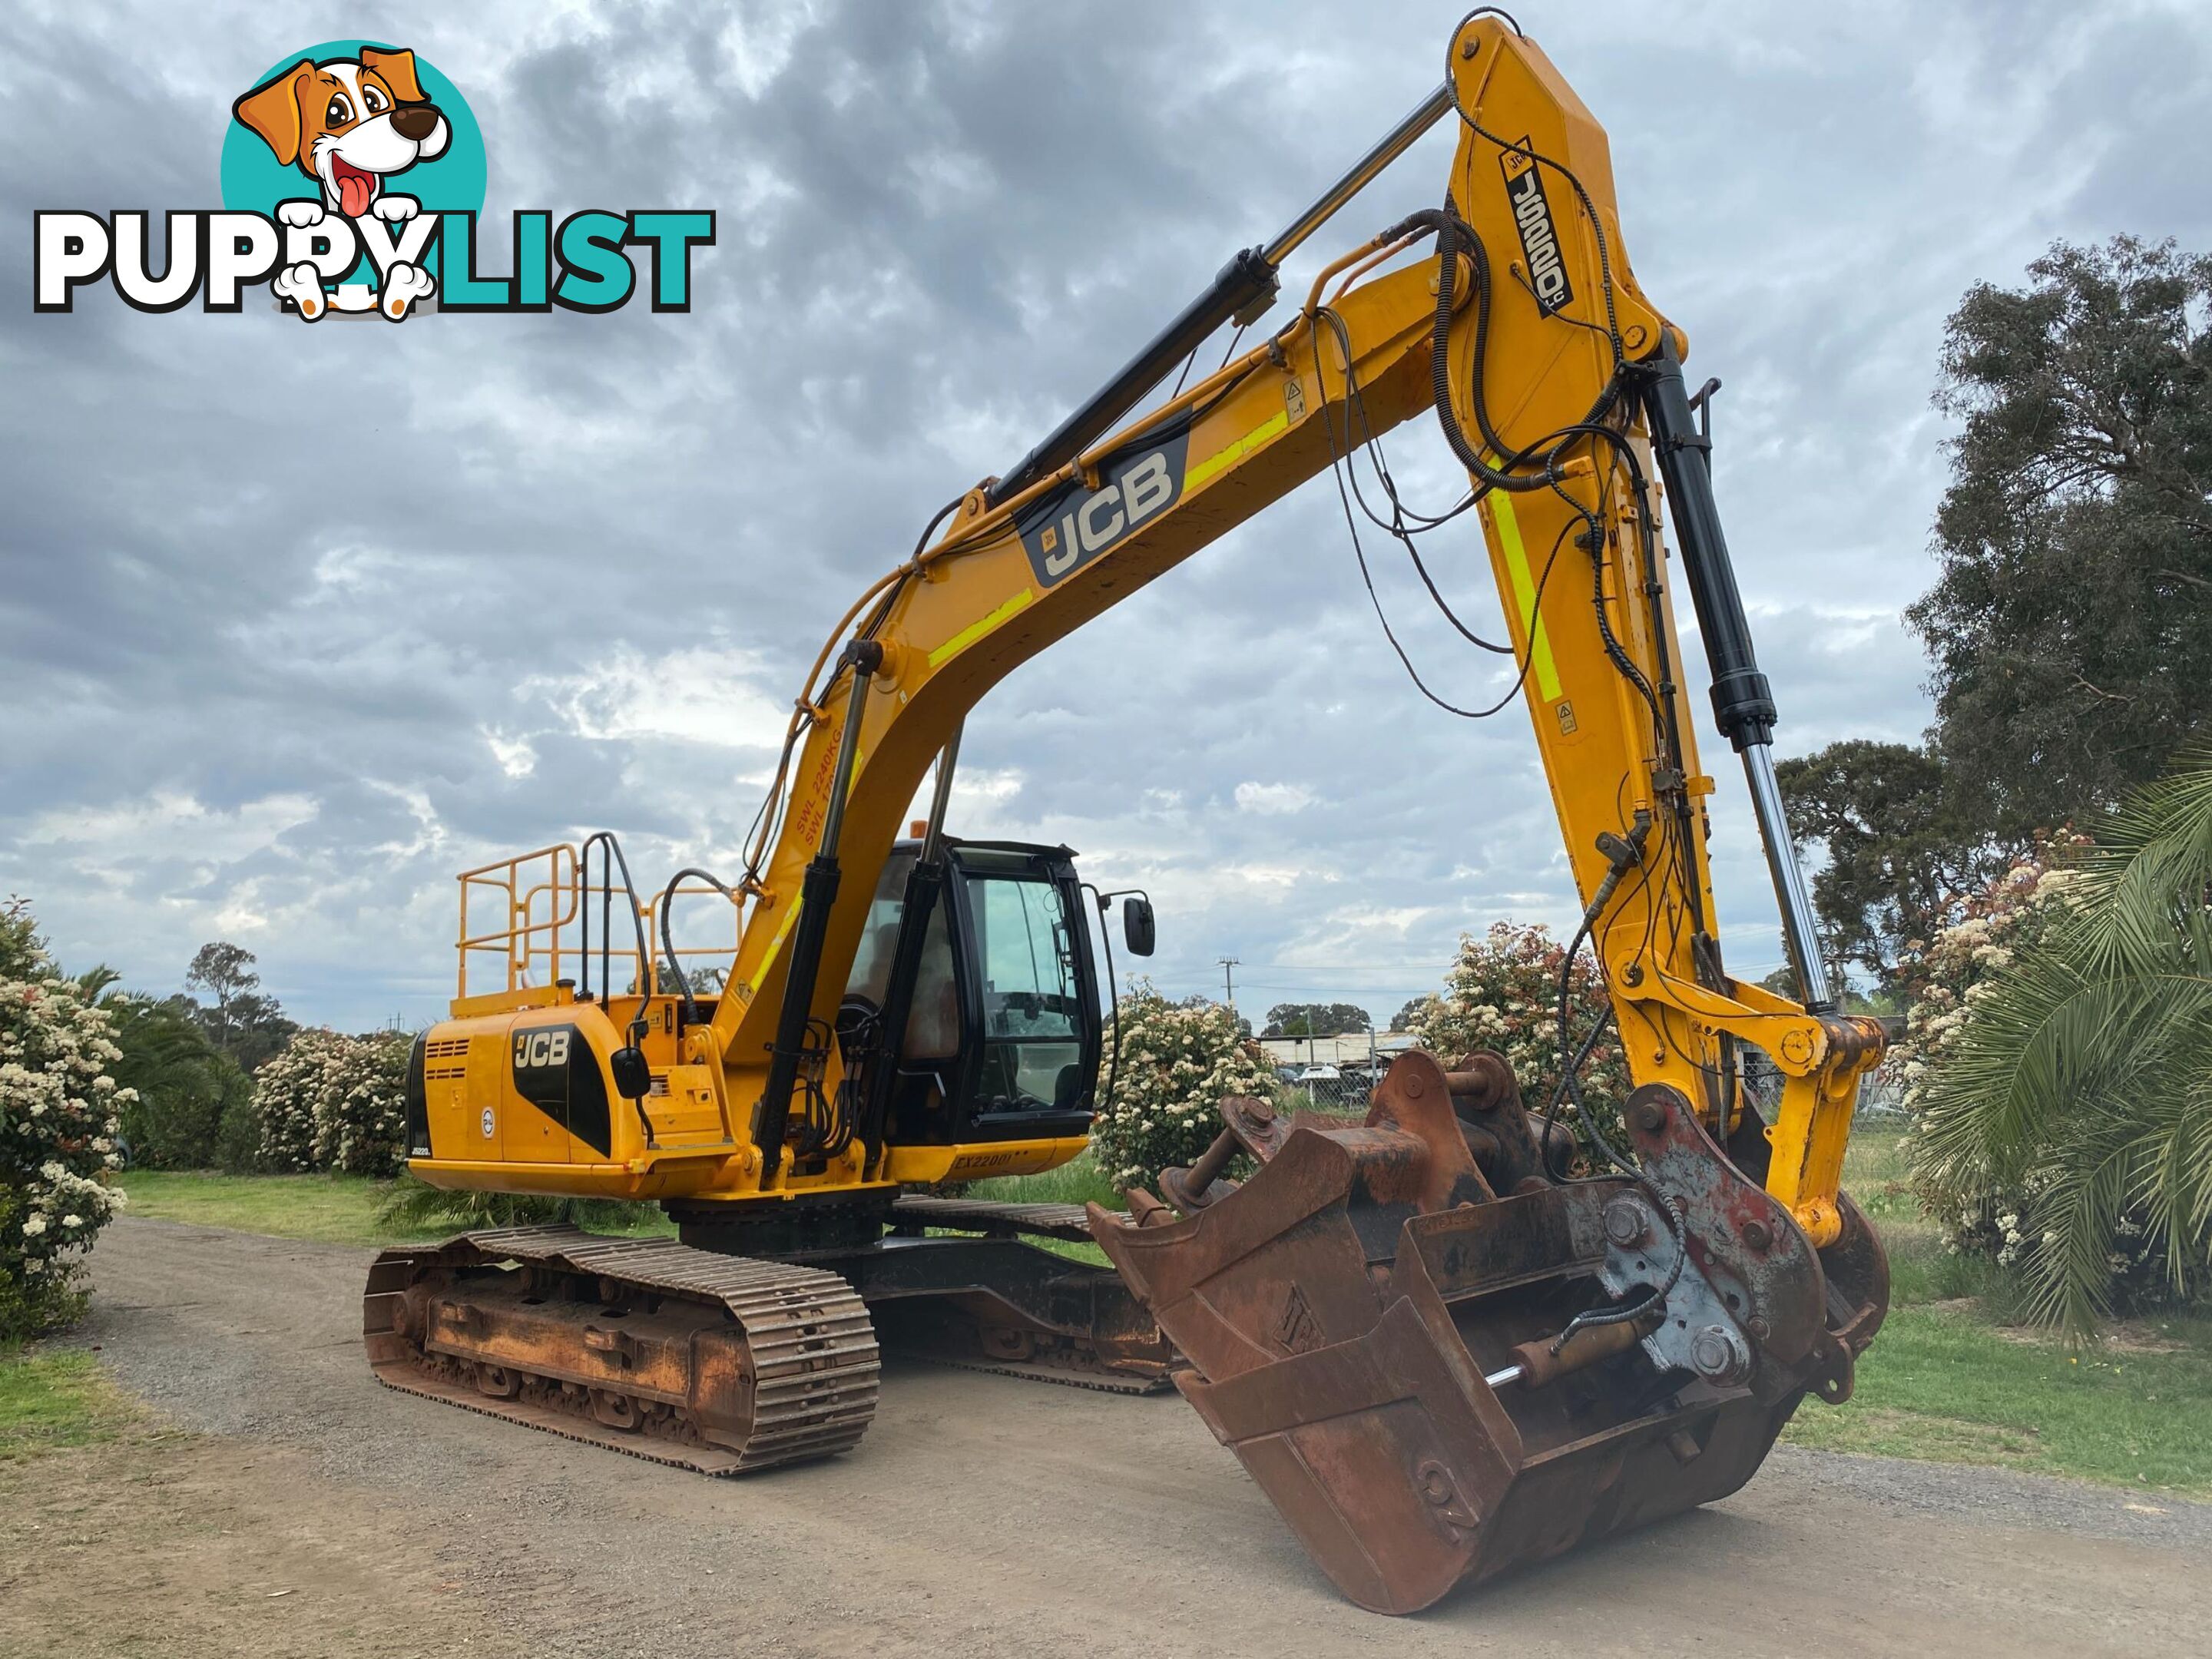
[30,1219,2212,1659]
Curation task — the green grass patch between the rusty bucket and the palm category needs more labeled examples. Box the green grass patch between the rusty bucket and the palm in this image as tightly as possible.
[1783,1131,2212,1495]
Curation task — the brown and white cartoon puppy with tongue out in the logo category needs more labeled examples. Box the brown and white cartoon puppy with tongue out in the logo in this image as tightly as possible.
[230,46,453,323]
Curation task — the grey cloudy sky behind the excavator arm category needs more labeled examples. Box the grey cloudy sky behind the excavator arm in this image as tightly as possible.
[0,0,2212,1026]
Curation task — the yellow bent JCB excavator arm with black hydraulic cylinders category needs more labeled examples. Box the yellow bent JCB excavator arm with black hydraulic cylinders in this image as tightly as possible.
[712,15,1880,1245]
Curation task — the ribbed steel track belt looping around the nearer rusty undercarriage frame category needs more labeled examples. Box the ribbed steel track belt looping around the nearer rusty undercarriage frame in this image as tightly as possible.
[363,1227,880,1475]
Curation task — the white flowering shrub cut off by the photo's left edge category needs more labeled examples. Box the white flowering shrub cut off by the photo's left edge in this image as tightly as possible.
[0,900,131,1340]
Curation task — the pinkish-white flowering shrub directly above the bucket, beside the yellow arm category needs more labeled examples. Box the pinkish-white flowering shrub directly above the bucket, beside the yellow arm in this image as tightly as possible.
[1409,922,1632,1146]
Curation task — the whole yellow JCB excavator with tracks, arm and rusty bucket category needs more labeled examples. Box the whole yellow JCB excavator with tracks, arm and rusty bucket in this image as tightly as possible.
[365,7,1889,1613]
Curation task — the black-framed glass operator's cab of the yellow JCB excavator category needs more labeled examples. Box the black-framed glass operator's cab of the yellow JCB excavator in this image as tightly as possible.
[839,836,1101,1146]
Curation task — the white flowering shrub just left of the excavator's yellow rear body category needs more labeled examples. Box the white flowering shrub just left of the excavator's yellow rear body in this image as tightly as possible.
[254,1031,414,1174]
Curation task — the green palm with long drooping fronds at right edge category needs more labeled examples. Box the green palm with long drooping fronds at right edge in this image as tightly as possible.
[1916,752,2212,1336]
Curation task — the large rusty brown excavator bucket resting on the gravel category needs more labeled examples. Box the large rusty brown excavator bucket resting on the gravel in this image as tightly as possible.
[1088,1051,1889,1613]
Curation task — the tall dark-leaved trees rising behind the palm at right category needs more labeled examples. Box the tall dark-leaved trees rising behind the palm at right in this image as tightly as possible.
[1780,237,2212,993]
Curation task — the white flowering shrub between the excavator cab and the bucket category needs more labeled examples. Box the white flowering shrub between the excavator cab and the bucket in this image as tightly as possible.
[1091,980,1274,1192]
